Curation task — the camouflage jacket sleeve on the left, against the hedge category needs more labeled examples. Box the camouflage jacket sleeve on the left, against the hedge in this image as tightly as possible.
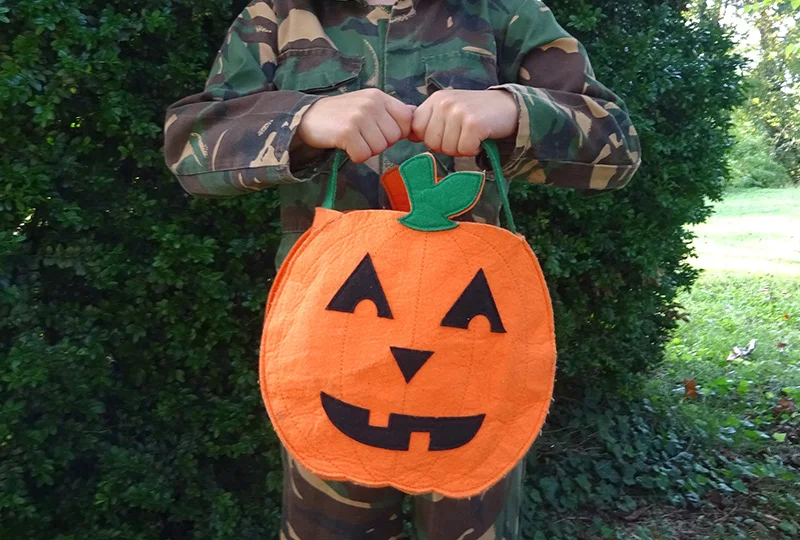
[164,0,318,197]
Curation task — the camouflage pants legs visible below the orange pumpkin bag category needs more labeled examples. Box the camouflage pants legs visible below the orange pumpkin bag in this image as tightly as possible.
[280,450,525,540]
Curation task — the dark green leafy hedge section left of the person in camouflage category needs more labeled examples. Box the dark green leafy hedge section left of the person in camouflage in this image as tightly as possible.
[0,0,280,540]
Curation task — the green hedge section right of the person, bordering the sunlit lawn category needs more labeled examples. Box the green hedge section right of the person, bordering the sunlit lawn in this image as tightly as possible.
[512,0,741,385]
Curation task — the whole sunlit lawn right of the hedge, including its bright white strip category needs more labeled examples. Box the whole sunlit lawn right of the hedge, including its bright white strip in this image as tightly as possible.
[654,189,800,444]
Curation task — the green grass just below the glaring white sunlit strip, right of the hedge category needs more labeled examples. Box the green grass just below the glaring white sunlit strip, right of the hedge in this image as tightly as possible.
[652,273,800,444]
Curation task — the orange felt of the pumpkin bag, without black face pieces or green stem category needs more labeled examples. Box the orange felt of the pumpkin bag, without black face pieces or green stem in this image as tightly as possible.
[260,207,556,498]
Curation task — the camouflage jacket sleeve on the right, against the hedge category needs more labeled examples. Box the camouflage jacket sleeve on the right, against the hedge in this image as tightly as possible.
[494,0,641,190]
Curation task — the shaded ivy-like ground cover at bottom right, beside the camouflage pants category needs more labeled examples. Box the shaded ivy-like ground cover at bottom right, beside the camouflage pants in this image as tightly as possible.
[522,392,800,540]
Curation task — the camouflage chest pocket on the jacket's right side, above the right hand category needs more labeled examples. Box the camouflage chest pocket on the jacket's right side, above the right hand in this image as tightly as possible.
[420,50,499,99]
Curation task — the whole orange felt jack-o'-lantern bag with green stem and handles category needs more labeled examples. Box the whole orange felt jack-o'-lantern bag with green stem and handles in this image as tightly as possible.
[260,142,556,498]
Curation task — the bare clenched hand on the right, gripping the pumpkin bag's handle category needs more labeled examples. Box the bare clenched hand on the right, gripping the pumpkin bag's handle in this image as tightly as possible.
[409,90,519,157]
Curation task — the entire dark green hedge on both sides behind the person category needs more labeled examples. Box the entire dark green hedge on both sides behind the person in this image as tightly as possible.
[0,0,739,540]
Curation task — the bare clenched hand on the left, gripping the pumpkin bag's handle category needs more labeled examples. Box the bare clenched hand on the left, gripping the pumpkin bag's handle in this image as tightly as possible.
[295,88,415,163]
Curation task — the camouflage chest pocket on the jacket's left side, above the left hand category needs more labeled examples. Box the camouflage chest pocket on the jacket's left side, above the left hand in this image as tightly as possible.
[275,48,363,95]
